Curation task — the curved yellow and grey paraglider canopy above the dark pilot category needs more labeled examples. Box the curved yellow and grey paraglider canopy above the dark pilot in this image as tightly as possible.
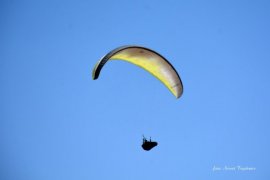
[92,46,183,98]
